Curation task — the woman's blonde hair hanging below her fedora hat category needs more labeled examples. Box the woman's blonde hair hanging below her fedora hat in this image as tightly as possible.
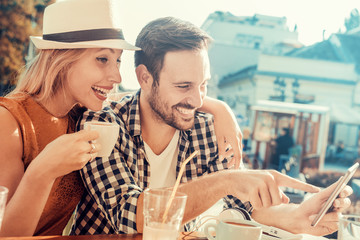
[7,49,87,102]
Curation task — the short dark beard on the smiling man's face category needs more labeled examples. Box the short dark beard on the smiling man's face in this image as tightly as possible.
[148,86,195,130]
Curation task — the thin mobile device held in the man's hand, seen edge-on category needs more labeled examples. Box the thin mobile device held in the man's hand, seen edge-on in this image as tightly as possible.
[311,163,359,226]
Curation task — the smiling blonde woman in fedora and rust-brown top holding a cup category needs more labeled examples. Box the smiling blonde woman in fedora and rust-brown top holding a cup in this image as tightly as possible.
[0,0,241,236]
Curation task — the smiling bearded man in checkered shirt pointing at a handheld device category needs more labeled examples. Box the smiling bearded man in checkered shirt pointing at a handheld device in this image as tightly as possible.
[72,17,351,235]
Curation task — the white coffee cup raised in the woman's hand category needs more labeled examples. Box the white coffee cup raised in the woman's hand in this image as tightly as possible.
[84,122,120,157]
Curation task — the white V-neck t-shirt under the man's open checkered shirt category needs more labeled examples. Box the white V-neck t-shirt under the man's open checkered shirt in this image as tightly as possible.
[144,130,180,188]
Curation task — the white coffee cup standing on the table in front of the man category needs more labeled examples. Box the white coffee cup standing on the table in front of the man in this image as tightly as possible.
[204,219,262,240]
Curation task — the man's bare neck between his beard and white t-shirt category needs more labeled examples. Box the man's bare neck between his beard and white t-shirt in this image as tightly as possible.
[140,94,176,155]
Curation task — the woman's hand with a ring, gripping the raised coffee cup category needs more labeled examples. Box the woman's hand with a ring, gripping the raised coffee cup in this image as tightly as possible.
[31,130,101,179]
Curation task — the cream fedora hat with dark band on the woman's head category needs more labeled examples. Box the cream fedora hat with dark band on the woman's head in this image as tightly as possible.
[30,0,140,50]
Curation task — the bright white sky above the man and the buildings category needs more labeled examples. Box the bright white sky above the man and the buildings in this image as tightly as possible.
[120,0,360,89]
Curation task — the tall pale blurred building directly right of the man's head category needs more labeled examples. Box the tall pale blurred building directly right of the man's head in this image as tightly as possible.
[202,12,302,95]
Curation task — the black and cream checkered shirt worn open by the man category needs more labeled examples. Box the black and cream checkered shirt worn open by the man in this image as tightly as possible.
[71,91,251,235]
